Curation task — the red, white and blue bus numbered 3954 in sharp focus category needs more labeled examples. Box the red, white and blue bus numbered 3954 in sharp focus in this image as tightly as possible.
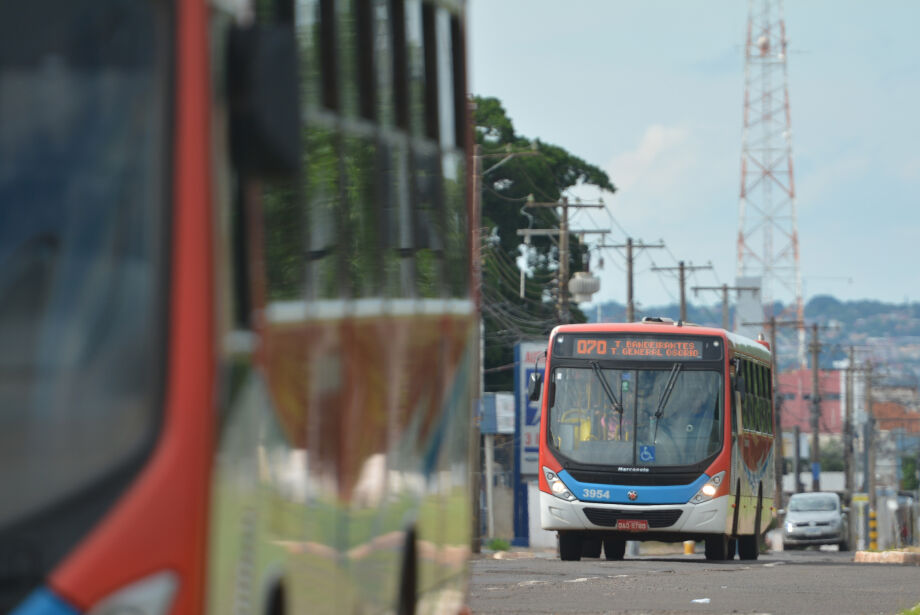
[531,318,774,560]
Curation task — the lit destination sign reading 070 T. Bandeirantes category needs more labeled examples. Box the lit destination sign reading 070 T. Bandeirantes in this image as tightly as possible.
[553,334,722,361]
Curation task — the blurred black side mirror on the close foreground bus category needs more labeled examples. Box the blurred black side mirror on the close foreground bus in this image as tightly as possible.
[227,23,301,178]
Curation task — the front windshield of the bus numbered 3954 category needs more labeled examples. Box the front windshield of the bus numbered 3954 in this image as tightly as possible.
[549,362,723,467]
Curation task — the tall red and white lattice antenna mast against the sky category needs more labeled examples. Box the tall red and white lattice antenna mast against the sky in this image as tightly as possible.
[738,0,805,365]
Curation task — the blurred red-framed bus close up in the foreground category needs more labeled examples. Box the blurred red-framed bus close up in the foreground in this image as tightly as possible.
[0,0,478,615]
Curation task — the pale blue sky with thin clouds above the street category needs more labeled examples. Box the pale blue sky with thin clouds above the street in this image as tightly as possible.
[468,0,920,307]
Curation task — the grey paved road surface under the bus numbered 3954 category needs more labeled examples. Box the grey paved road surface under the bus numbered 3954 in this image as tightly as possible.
[470,550,920,615]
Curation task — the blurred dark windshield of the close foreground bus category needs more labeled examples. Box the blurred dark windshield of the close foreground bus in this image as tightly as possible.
[0,0,172,530]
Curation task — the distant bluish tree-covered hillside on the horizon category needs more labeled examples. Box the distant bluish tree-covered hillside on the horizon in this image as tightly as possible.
[584,295,920,386]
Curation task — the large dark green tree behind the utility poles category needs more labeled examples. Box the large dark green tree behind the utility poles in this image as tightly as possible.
[473,96,616,390]
